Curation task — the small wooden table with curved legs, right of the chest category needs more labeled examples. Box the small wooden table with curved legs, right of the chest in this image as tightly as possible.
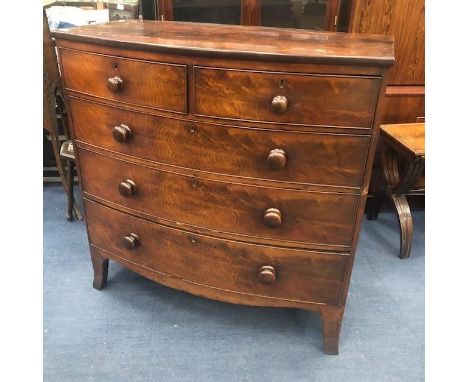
[367,123,425,259]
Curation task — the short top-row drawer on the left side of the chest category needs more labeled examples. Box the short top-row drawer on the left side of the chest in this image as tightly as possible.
[60,49,187,113]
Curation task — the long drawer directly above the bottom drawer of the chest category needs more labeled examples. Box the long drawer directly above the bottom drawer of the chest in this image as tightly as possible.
[78,148,358,247]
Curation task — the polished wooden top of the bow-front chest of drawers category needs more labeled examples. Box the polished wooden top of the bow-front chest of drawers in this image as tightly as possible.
[52,20,394,66]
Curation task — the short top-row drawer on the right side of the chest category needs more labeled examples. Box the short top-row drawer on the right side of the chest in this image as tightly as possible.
[194,67,380,128]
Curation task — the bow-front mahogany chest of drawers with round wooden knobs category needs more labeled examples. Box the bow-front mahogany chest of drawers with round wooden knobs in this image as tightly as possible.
[53,21,394,354]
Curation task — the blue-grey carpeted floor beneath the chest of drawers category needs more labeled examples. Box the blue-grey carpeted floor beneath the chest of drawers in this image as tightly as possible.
[44,187,424,382]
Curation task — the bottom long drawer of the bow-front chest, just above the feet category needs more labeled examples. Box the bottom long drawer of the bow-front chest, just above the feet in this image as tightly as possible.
[85,201,348,303]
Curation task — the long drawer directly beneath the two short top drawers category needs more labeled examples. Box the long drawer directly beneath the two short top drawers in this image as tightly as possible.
[70,98,369,187]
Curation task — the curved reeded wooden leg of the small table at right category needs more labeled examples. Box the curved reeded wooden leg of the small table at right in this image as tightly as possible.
[382,143,424,259]
